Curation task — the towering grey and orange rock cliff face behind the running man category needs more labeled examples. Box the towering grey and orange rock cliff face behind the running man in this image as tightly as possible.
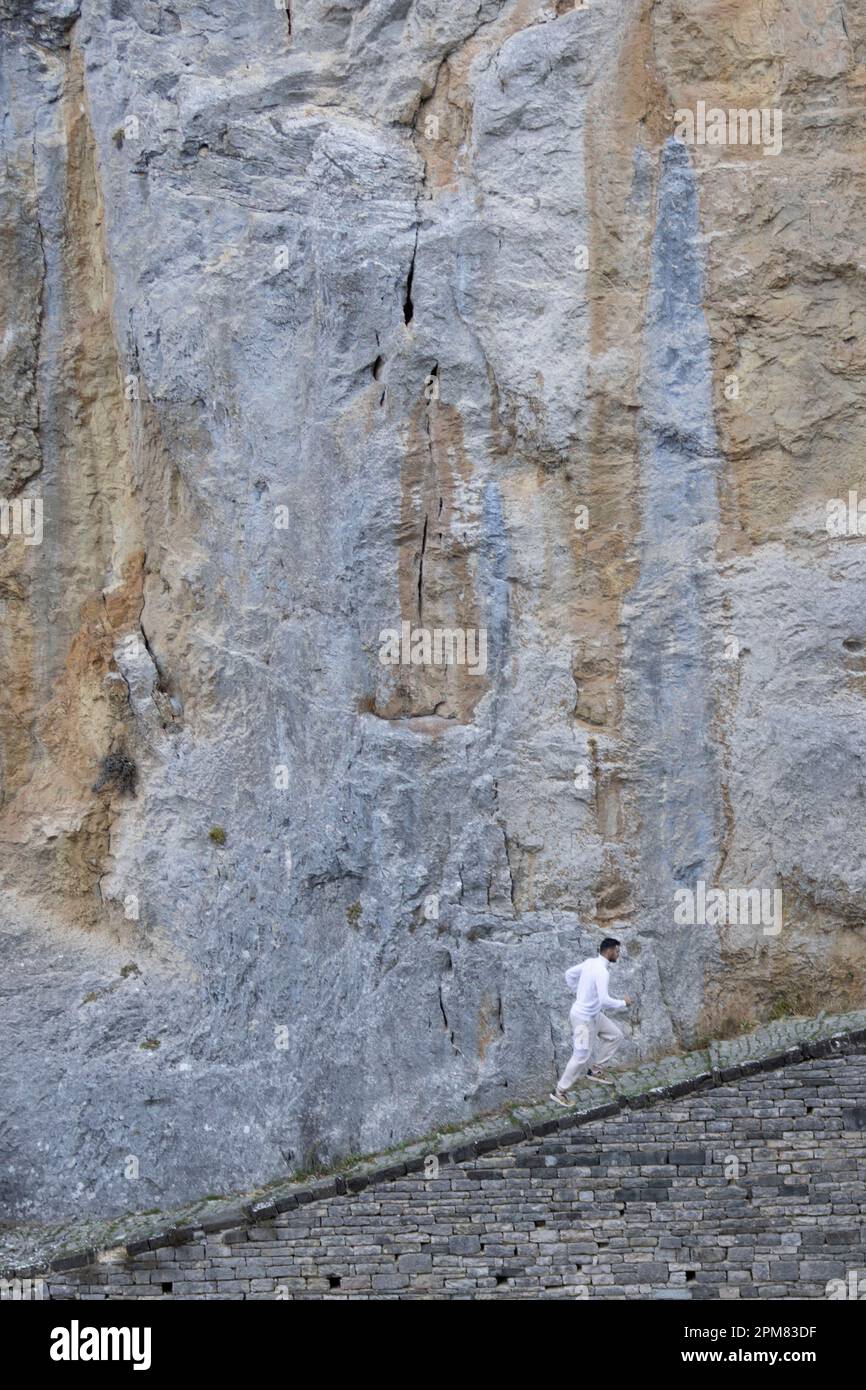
[0,0,866,1218]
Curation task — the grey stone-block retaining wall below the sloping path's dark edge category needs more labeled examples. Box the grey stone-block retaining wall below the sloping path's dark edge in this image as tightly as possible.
[35,1055,866,1300]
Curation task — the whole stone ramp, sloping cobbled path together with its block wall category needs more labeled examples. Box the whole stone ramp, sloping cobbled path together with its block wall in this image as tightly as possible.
[7,1013,866,1297]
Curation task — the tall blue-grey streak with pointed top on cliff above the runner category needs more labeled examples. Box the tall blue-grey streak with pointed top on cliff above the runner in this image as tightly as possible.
[626,139,724,1034]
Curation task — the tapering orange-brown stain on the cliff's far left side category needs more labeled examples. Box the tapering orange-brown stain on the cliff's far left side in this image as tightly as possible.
[0,49,145,924]
